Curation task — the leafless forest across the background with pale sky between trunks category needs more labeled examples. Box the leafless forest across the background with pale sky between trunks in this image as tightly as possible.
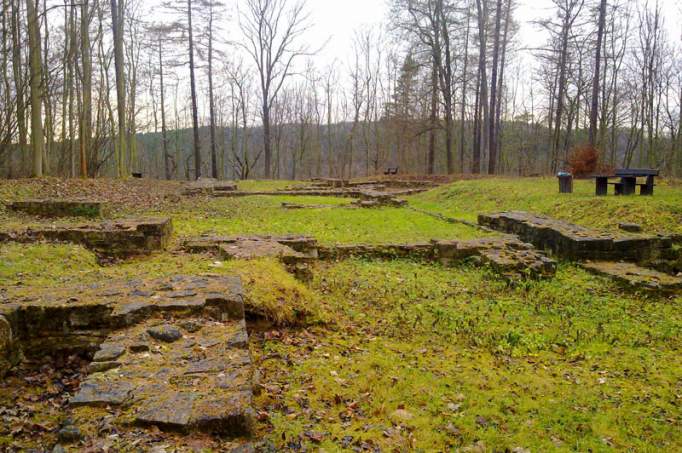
[0,0,682,179]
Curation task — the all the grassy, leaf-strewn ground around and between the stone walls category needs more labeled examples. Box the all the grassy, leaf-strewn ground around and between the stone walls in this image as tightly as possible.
[0,179,682,452]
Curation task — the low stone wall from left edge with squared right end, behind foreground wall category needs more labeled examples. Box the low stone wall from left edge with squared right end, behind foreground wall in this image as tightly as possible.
[0,218,173,260]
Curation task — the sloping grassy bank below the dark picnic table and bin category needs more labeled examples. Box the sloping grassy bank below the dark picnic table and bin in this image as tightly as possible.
[409,178,682,234]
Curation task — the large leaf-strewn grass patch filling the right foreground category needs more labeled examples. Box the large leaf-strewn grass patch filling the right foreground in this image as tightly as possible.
[259,261,682,451]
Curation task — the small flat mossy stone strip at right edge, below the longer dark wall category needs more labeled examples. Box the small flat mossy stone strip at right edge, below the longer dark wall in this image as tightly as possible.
[581,261,682,293]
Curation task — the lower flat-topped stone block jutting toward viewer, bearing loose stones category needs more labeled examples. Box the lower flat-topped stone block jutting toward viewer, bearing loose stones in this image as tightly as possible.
[70,318,254,436]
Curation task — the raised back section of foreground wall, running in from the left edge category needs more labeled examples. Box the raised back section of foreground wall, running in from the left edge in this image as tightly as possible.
[0,275,244,366]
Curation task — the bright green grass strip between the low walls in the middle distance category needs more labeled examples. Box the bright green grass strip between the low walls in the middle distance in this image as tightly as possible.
[137,196,483,244]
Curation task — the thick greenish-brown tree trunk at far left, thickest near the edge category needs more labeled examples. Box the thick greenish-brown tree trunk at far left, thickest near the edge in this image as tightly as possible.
[26,0,45,177]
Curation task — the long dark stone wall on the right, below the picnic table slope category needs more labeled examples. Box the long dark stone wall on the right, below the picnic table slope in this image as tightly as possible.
[478,211,677,264]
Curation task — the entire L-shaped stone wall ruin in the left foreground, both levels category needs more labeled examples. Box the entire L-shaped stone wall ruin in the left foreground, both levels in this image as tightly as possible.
[0,276,253,436]
